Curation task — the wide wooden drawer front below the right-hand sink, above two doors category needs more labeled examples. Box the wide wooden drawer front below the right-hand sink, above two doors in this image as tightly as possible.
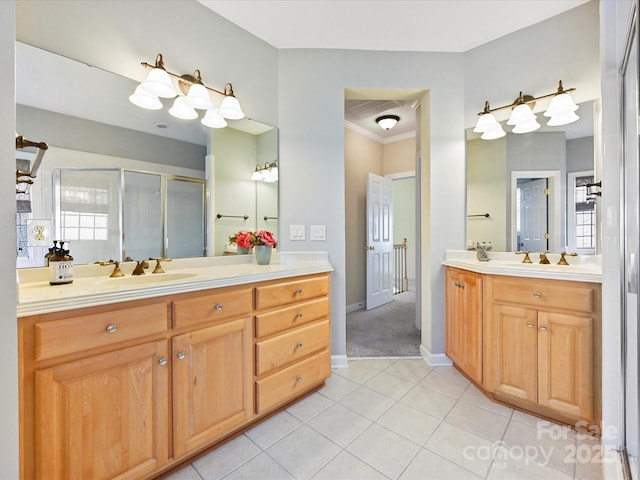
[492,277,595,313]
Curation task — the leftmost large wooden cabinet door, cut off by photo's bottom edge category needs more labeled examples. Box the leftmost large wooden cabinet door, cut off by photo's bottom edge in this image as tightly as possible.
[35,341,169,480]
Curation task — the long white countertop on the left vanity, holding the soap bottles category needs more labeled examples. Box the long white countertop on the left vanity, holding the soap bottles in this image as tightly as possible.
[17,252,333,317]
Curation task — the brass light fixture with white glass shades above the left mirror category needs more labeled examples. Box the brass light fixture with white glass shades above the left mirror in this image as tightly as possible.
[129,53,244,128]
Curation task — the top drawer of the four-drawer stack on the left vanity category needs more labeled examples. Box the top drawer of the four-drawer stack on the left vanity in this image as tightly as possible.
[256,275,329,310]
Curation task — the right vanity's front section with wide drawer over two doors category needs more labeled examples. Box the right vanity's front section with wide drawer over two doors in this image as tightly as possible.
[484,276,600,423]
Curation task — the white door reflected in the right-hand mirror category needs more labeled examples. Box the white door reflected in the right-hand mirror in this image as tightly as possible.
[518,178,548,252]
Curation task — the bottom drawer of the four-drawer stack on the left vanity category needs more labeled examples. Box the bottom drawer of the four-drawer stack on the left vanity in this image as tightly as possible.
[256,350,331,413]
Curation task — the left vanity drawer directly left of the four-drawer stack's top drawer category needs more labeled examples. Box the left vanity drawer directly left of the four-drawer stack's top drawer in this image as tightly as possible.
[173,288,252,328]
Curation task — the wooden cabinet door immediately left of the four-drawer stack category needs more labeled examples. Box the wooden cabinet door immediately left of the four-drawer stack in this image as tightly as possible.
[172,318,253,458]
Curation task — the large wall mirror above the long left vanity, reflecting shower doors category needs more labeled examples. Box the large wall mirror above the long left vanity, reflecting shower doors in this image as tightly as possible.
[16,42,278,267]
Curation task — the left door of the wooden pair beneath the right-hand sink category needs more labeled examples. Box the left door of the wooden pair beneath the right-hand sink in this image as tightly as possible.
[484,305,538,403]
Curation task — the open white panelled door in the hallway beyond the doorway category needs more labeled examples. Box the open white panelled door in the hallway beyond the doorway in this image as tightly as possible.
[365,173,393,310]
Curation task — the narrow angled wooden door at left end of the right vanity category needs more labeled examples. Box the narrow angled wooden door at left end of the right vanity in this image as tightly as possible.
[446,269,482,383]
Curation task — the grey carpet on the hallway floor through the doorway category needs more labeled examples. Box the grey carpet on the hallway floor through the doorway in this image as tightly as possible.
[347,291,420,358]
